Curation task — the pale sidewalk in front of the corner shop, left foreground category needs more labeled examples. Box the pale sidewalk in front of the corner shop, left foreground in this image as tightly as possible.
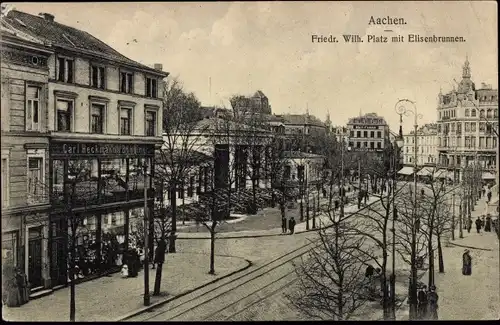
[2,253,250,321]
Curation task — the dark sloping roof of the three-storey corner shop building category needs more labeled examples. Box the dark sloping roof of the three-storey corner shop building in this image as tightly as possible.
[3,10,168,75]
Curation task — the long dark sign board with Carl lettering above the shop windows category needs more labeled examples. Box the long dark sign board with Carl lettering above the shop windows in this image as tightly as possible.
[50,142,155,156]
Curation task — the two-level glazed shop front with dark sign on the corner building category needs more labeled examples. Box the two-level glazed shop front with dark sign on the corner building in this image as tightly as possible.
[49,141,155,286]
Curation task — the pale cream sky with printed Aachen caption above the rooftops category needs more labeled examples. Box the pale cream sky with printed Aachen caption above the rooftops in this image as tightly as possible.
[7,1,498,133]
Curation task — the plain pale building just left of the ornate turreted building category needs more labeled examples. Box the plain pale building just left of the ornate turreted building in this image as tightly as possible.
[402,123,438,166]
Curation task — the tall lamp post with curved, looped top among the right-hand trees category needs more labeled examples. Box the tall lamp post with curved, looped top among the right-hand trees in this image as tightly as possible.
[394,99,423,319]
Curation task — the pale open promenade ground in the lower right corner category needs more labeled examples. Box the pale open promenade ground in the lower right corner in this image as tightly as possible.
[397,205,500,320]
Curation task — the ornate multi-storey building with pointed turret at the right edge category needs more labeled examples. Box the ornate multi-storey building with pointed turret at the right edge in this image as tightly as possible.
[437,55,498,177]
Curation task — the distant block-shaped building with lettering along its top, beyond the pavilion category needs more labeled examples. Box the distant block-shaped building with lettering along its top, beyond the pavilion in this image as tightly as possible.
[347,113,389,154]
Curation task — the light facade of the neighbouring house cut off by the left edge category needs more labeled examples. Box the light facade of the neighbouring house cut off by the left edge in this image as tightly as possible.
[0,17,53,288]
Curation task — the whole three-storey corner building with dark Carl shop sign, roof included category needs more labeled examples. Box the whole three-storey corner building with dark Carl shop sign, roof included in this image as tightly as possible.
[2,10,168,287]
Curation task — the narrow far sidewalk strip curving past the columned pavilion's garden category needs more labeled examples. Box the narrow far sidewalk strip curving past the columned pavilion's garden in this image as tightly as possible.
[177,196,379,239]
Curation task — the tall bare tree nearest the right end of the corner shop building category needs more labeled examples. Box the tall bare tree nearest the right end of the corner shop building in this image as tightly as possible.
[160,78,207,253]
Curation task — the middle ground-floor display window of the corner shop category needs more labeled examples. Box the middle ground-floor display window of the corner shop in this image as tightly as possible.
[101,211,125,269]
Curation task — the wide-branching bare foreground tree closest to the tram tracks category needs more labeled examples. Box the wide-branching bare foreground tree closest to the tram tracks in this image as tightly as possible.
[288,134,373,320]
